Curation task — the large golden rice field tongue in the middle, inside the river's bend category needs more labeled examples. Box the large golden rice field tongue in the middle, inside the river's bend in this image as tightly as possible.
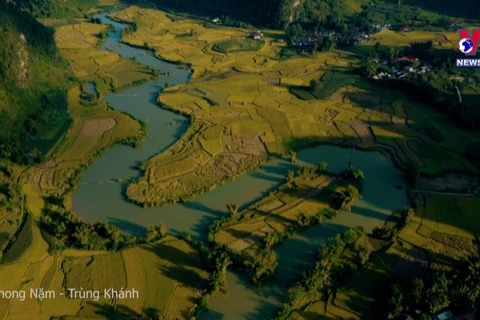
[108,6,480,206]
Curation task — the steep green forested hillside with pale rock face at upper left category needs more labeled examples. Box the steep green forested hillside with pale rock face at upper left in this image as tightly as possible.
[0,0,69,163]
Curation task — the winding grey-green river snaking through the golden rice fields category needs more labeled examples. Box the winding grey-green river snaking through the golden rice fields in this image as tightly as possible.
[72,14,409,320]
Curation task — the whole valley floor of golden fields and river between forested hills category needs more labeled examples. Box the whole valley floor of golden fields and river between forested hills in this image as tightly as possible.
[0,2,480,319]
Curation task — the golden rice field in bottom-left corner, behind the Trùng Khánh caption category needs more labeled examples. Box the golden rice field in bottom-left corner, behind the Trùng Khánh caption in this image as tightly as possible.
[0,221,208,320]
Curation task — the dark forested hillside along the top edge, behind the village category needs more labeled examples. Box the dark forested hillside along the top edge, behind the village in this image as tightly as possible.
[150,0,480,28]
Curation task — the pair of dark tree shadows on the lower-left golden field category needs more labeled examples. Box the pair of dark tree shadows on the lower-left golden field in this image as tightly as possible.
[145,242,204,289]
